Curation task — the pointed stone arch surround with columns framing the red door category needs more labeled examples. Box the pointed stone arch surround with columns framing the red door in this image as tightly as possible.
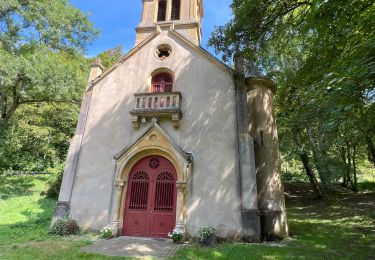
[111,120,192,235]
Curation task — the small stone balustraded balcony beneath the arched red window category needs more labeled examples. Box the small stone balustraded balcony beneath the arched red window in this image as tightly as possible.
[130,92,182,128]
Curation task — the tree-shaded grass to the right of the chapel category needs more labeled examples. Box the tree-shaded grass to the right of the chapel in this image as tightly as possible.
[174,185,375,260]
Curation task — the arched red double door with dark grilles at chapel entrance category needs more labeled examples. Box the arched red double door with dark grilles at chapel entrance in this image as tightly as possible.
[122,156,177,237]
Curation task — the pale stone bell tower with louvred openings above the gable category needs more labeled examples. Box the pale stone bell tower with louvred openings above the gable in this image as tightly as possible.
[135,0,203,45]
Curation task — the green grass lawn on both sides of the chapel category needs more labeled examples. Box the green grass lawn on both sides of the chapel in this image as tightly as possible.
[0,176,375,259]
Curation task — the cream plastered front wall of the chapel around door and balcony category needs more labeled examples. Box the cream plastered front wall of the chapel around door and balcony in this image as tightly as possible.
[71,31,241,237]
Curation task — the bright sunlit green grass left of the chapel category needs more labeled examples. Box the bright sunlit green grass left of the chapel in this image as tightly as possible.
[0,176,122,260]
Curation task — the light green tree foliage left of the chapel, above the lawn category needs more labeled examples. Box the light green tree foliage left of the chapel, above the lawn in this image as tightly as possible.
[0,0,97,177]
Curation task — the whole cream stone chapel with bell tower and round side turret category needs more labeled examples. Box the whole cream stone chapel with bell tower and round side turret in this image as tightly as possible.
[54,0,288,241]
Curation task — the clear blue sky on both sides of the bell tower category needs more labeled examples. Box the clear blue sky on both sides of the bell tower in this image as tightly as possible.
[70,0,232,57]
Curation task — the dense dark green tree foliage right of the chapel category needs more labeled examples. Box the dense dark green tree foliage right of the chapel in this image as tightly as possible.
[210,0,375,194]
